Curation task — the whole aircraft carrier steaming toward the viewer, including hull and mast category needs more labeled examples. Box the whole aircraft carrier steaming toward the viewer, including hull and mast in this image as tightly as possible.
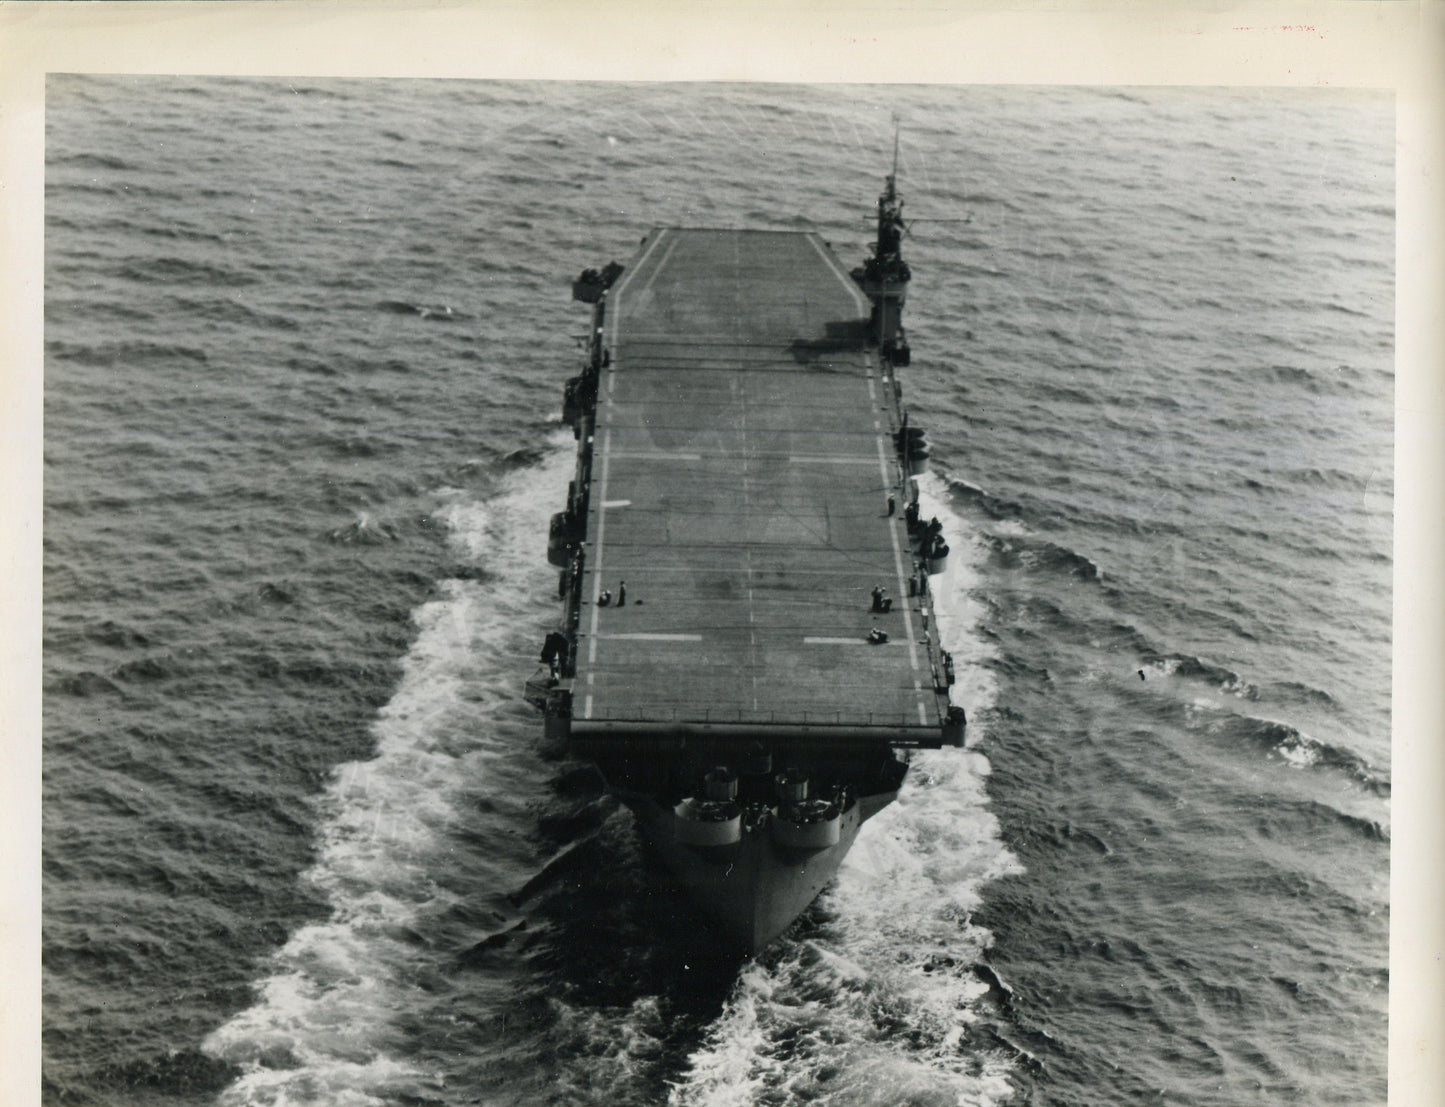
[527,168,965,952]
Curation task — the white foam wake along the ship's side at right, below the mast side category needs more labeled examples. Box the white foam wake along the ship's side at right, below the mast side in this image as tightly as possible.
[672,475,1020,1107]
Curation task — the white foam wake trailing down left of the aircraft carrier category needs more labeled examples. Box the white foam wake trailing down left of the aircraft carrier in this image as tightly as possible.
[204,438,572,1107]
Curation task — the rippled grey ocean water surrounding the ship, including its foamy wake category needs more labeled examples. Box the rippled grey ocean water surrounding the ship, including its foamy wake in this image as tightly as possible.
[43,77,1394,1107]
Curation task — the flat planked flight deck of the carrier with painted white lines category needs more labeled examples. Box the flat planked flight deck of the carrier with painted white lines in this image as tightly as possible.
[572,230,946,736]
